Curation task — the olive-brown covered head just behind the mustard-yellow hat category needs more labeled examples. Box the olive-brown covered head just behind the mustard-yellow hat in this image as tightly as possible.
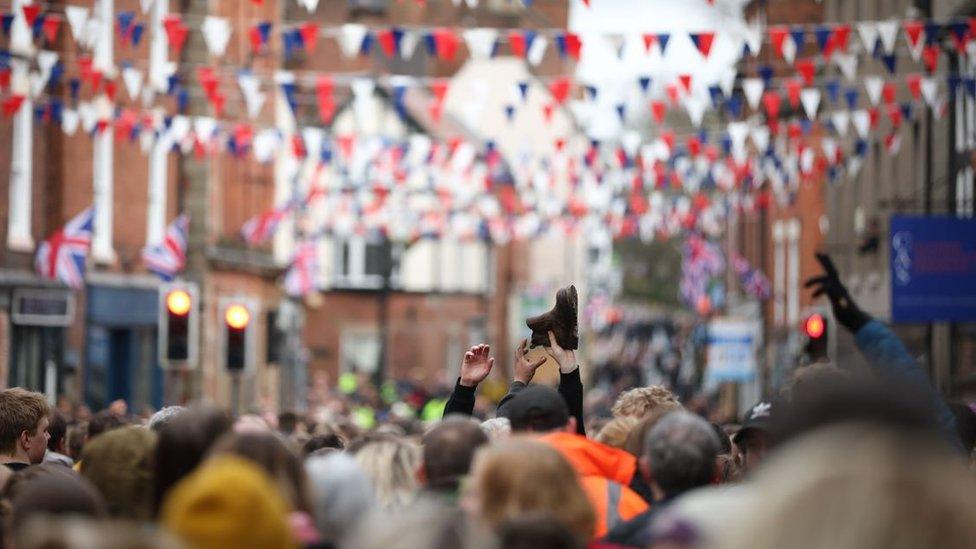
[81,426,156,521]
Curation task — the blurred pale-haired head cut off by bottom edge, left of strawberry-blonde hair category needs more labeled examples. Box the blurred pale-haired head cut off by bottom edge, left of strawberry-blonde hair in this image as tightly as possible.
[342,499,497,549]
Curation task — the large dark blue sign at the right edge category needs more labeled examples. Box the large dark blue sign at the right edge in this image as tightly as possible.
[890,216,976,323]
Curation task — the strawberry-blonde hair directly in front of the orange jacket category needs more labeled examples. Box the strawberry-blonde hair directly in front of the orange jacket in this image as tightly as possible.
[469,437,596,541]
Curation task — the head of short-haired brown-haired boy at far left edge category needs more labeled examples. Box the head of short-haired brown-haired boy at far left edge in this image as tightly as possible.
[0,387,51,463]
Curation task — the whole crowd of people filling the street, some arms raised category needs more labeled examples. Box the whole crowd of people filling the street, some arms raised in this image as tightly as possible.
[0,257,976,549]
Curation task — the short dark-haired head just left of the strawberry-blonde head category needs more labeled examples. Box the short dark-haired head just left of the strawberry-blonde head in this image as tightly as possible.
[419,417,488,492]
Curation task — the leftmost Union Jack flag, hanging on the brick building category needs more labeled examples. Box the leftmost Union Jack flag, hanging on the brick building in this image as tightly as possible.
[34,208,95,290]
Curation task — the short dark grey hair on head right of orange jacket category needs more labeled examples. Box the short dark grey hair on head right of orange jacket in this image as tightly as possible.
[644,410,721,497]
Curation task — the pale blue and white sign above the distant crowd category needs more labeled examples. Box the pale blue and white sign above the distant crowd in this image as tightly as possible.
[705,317,759,383]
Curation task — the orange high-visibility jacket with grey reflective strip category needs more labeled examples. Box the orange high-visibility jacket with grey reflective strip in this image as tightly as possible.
[542,432,648,538]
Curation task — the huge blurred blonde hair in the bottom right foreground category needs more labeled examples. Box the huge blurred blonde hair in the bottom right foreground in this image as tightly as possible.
[716,424,976,549]
